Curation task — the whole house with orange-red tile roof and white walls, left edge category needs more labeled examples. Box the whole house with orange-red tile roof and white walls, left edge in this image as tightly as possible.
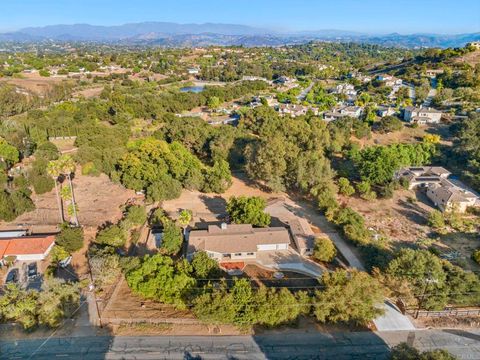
[0,235,55,261]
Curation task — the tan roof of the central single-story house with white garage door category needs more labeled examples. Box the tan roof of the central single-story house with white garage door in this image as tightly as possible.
[188,224,290,253]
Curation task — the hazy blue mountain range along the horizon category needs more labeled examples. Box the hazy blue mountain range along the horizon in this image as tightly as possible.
[0,22,480,48]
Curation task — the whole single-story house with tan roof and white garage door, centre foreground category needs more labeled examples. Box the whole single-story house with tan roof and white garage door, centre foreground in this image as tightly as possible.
[187,223,290,262]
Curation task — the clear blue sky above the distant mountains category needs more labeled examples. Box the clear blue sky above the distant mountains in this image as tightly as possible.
[0,0,480,34]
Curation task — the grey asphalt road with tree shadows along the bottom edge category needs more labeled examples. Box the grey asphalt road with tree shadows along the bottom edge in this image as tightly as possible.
[0,330,480,360]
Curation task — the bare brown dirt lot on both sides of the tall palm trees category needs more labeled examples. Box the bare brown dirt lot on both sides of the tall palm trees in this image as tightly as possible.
[0,171,136,232]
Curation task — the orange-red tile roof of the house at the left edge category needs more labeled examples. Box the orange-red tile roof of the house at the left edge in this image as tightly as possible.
[0,235,55,258]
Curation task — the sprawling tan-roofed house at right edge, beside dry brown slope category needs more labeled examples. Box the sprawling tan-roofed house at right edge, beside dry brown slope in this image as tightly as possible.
[395,166,480,212]
